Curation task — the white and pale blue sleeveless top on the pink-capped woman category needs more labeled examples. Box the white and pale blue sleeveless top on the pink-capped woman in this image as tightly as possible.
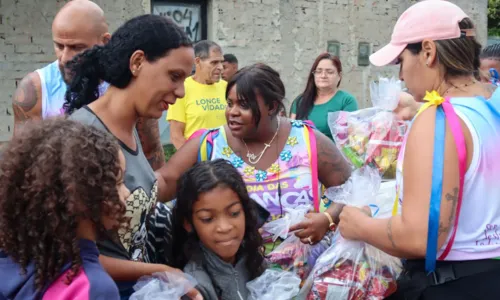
[396,89,500,261]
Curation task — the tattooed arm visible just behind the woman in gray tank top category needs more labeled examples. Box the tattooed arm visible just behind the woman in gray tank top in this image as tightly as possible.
[136,118,165,171]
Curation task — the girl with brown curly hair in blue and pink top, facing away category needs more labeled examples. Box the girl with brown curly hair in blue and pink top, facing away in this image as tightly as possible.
[0,119,130,300]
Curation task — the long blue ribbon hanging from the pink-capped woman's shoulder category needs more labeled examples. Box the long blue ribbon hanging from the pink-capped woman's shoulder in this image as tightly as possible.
[425,105,446,273]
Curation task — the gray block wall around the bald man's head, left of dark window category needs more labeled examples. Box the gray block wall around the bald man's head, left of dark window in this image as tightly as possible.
[0,0,150,141]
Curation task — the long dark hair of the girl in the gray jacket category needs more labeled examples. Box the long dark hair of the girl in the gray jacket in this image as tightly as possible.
[173,159,265,279]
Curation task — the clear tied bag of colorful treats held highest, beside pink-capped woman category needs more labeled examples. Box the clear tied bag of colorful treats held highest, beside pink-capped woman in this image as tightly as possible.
[328,78,407,179]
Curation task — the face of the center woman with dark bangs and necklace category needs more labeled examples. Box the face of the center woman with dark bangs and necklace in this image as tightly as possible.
[226,84,270,139]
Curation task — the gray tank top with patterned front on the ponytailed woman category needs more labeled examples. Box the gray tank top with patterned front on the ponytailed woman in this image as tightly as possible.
[70,106,158,261]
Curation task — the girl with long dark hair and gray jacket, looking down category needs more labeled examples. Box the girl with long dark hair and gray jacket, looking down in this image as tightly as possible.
[173,159,264,300]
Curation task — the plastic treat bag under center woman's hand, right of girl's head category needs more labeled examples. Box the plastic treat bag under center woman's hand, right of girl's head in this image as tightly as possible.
[262,205,330,280]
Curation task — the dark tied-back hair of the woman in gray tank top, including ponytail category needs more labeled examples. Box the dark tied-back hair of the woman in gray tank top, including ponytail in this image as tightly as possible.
[64,14,192,114]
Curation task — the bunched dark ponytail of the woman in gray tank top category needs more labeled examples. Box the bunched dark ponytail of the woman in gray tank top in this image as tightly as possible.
[63,46,105,114]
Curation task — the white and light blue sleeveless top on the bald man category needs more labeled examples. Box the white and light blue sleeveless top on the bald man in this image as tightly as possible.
[36,60,109,119]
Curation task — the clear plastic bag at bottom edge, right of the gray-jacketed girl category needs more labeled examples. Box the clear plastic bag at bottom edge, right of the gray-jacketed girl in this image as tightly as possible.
[247,269,301,300]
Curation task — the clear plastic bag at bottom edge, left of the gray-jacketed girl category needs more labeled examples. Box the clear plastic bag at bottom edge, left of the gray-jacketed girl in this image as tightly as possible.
[130,272,197,300]
